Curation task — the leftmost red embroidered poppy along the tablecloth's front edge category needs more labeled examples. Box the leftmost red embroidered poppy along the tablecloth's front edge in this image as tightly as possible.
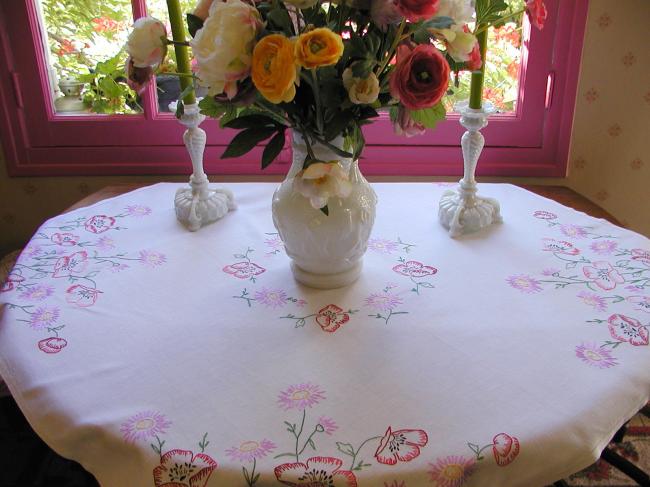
[153,450,217,487]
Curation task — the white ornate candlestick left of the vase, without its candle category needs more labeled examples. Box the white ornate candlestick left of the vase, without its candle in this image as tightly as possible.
[169,102,236,232]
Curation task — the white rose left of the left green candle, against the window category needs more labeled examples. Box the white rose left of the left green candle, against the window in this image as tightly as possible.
[126,17,167,68]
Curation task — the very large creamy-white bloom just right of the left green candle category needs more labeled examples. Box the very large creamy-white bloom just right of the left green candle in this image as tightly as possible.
[190,0,262,98]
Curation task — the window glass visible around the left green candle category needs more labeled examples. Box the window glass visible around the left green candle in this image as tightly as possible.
[147,0,205,112]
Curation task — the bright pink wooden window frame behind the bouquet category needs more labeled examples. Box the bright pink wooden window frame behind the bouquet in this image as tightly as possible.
[0,0,588,177]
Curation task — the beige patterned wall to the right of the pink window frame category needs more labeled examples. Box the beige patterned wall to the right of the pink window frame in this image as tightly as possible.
[568,0,650,236]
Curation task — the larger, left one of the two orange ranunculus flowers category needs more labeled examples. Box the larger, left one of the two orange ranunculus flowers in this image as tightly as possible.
[252,34,296,103]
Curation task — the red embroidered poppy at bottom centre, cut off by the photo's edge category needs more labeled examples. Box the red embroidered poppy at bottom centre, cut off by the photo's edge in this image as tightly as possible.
[274,457,357,487]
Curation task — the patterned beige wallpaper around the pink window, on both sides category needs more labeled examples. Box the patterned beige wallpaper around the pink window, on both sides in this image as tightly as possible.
[0,0,650,254]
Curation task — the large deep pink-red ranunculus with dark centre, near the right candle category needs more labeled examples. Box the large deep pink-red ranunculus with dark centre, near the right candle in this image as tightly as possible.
[390,44,449,110]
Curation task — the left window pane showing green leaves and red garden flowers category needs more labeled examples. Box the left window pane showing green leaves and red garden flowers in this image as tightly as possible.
[38,0,142,114]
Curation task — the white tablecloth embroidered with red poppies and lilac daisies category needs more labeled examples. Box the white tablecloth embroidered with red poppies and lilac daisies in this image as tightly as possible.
[0,184,650,487]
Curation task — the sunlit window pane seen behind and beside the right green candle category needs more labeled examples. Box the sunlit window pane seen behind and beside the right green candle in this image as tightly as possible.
[445,0,524,115]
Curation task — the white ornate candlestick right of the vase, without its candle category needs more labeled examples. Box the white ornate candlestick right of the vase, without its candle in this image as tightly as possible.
[438,102,503,238]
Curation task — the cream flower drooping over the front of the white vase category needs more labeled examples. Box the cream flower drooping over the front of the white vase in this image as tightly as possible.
[293,161,352,210]
